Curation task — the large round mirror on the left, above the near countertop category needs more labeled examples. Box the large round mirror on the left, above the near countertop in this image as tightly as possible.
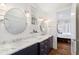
[4,8,26,34]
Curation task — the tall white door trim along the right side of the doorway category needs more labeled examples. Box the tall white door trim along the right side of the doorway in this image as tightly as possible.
[71,3,76,55]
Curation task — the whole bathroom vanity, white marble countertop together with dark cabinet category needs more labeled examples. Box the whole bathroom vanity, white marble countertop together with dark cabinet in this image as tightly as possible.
[0,34,53,55]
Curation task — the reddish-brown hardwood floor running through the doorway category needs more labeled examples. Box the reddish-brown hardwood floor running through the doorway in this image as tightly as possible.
[49,38,71,55]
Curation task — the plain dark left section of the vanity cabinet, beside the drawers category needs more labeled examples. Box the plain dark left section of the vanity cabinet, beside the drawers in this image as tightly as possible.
[12,44,38,55]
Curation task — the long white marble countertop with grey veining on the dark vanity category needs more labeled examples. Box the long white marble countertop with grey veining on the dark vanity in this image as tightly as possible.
[0,34,52,55]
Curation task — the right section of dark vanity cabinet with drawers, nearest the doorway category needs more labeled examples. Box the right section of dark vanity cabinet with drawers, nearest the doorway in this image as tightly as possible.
[38,37,53,55]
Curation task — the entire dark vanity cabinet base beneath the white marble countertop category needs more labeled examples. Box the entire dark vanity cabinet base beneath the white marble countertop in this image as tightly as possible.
[12,37,53,55]
